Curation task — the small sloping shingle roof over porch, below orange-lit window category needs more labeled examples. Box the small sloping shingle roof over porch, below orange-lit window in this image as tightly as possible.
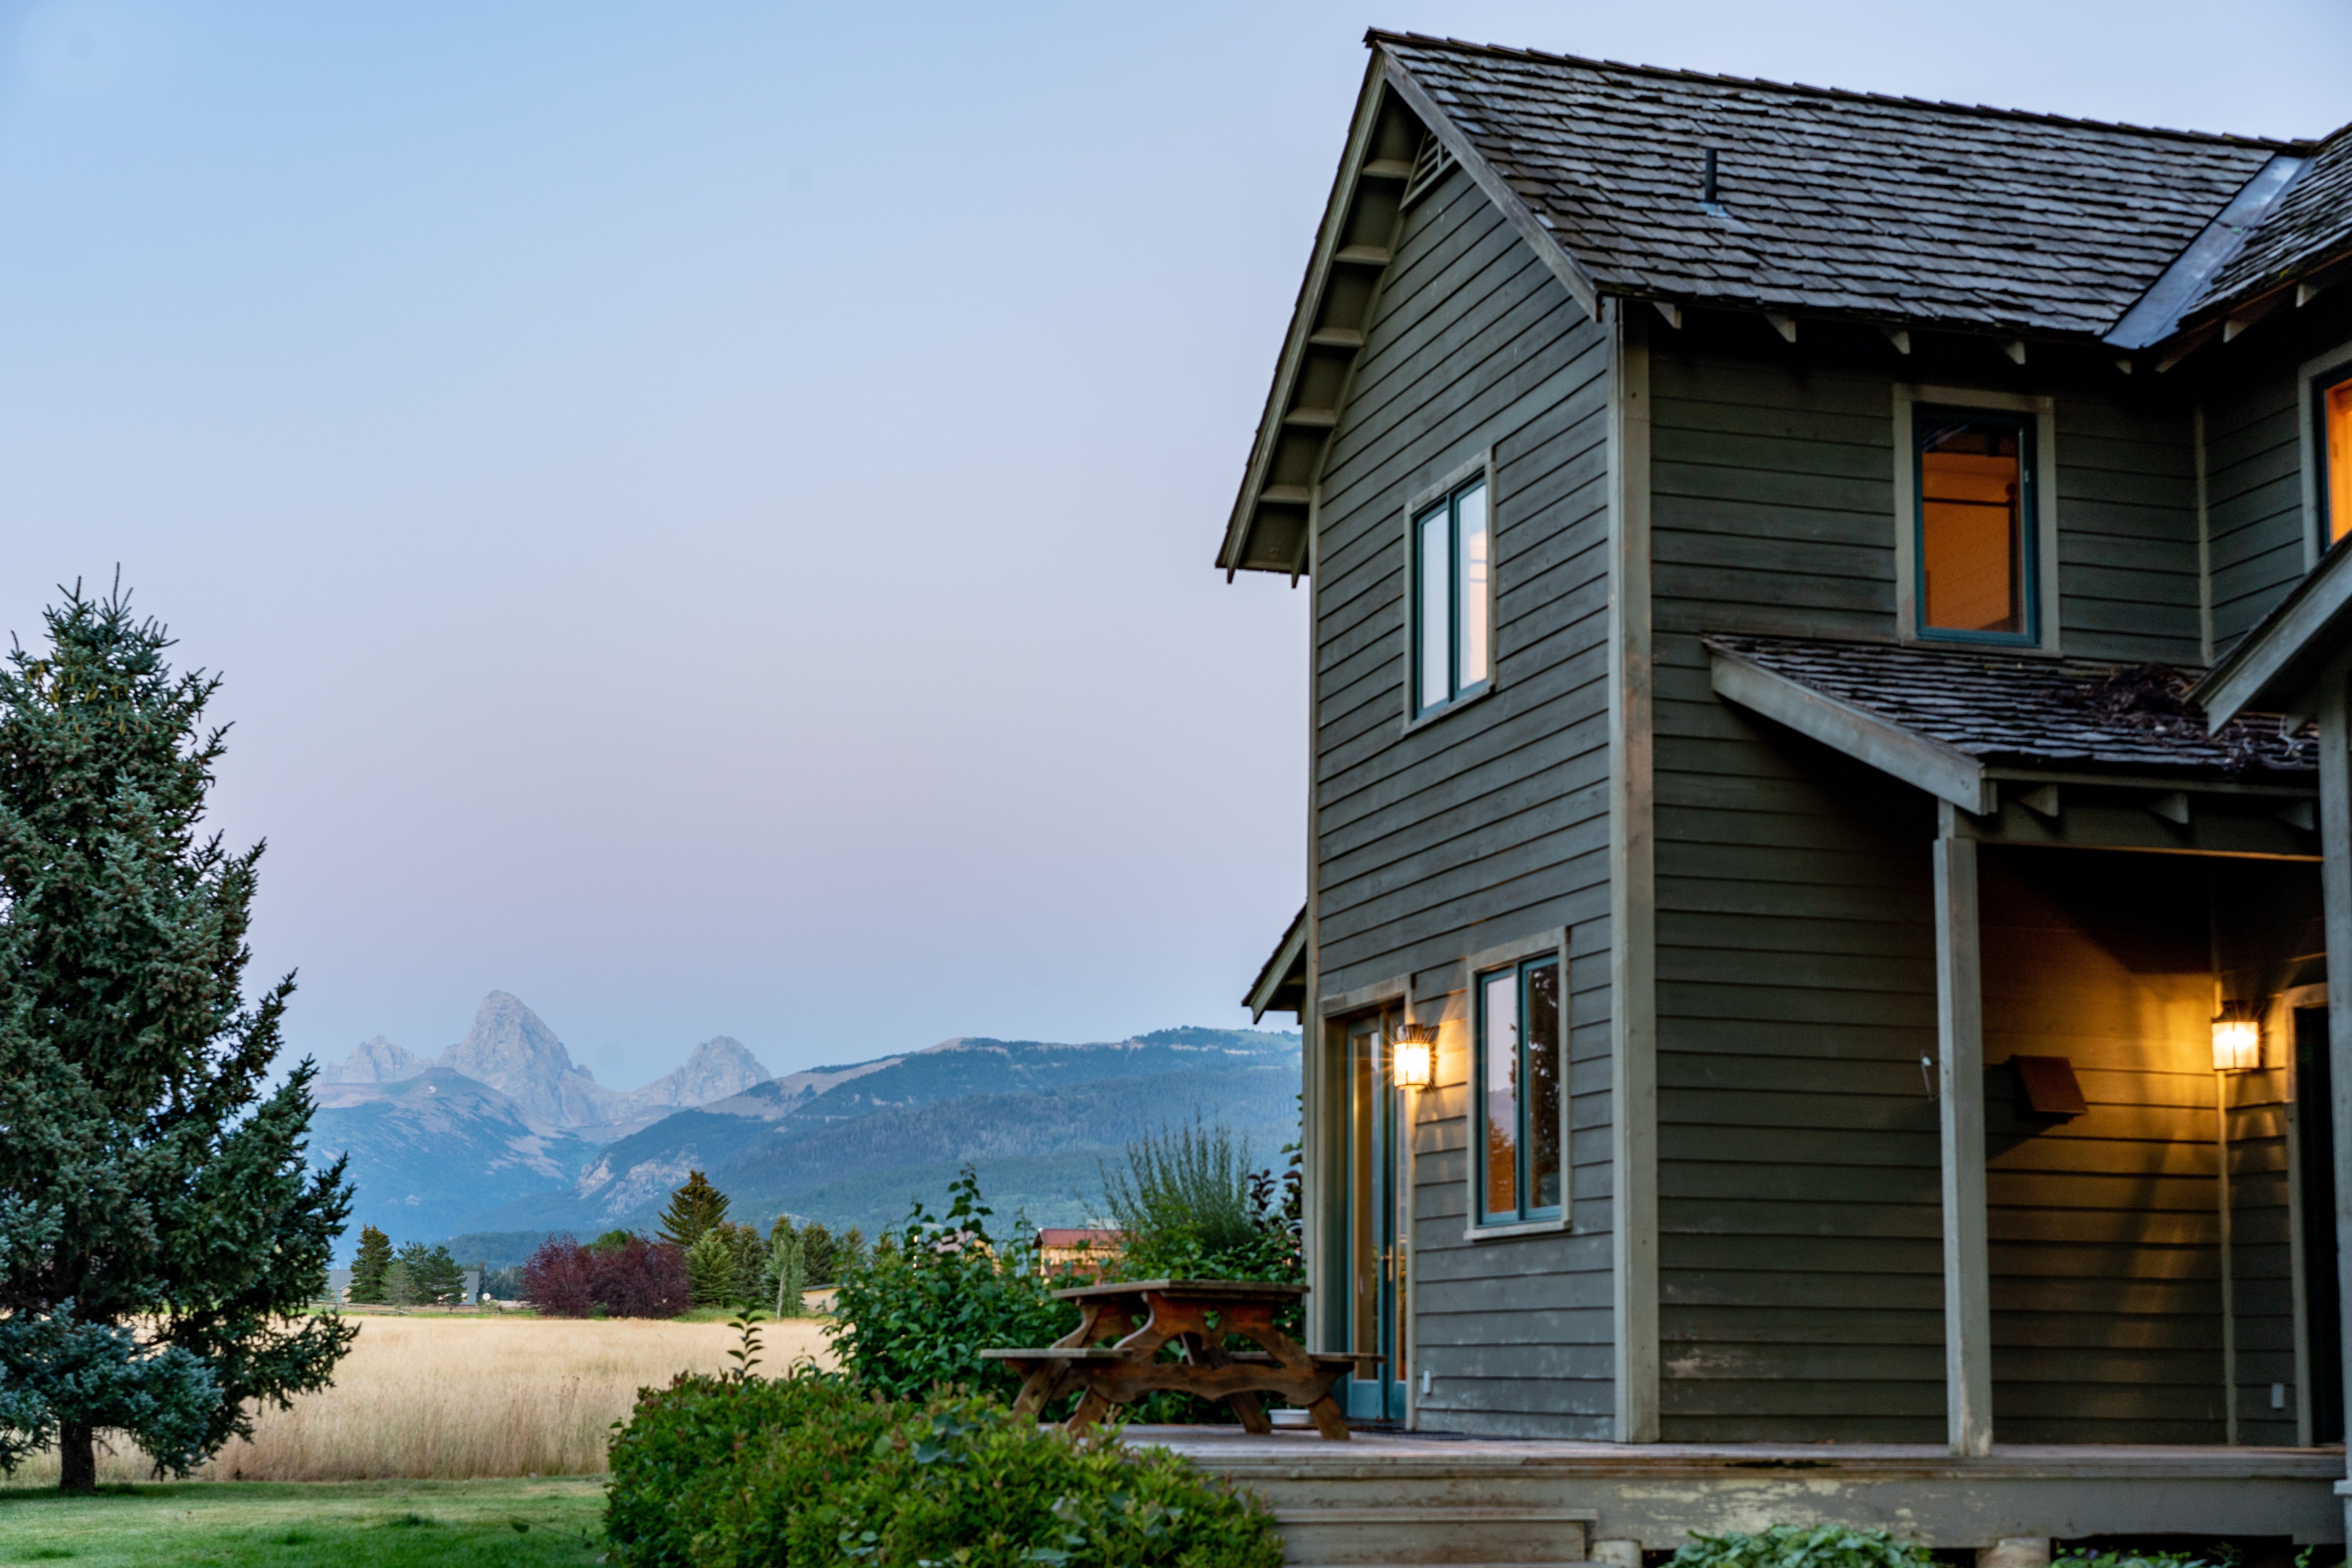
[1705,635,2319,783]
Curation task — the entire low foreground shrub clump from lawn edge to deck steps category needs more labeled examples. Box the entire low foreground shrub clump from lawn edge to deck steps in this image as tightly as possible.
[604,1373,1282,1568]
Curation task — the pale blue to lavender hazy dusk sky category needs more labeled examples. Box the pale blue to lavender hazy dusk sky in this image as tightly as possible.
[0,0,2352,1086]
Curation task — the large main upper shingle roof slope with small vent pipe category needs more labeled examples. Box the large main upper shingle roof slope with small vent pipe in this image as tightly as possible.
[1371,33,2307,336]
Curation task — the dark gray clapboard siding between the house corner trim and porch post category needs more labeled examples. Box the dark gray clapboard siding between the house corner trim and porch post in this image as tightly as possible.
[1651,334,1943,1441]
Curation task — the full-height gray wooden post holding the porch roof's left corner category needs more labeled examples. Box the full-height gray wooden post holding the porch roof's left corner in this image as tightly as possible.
[1936,832,1992,1455]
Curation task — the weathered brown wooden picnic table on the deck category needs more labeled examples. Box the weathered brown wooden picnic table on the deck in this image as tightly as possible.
[981,1279,1357,1441]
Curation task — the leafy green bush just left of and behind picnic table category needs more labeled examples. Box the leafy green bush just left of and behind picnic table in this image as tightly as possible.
[826,1166,1077,1399]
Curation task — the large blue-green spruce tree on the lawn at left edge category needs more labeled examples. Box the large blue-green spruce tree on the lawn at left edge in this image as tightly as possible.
[0,588,358,1490]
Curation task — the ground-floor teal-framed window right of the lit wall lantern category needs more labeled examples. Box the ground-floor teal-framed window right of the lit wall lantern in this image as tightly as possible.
[1477,959,1566,1225]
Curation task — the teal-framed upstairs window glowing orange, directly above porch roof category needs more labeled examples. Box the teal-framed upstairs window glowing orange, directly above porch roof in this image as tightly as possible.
[1912,407,2042,642]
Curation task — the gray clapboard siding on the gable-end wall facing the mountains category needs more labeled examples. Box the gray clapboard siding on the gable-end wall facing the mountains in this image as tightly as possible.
[1312,172,1613,1436]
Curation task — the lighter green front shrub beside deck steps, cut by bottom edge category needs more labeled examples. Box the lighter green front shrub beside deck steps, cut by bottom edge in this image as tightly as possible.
[694,1394,1282,1568]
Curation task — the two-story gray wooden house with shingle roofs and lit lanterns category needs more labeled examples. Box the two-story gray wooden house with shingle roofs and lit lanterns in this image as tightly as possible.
[1218,33,2352,1547]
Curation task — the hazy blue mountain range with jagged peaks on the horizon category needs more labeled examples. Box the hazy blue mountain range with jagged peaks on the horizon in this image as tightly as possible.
[310,992,1298,1255]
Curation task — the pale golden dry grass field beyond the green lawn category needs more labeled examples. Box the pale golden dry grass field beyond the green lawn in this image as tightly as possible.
[16,1316,830,1486]
